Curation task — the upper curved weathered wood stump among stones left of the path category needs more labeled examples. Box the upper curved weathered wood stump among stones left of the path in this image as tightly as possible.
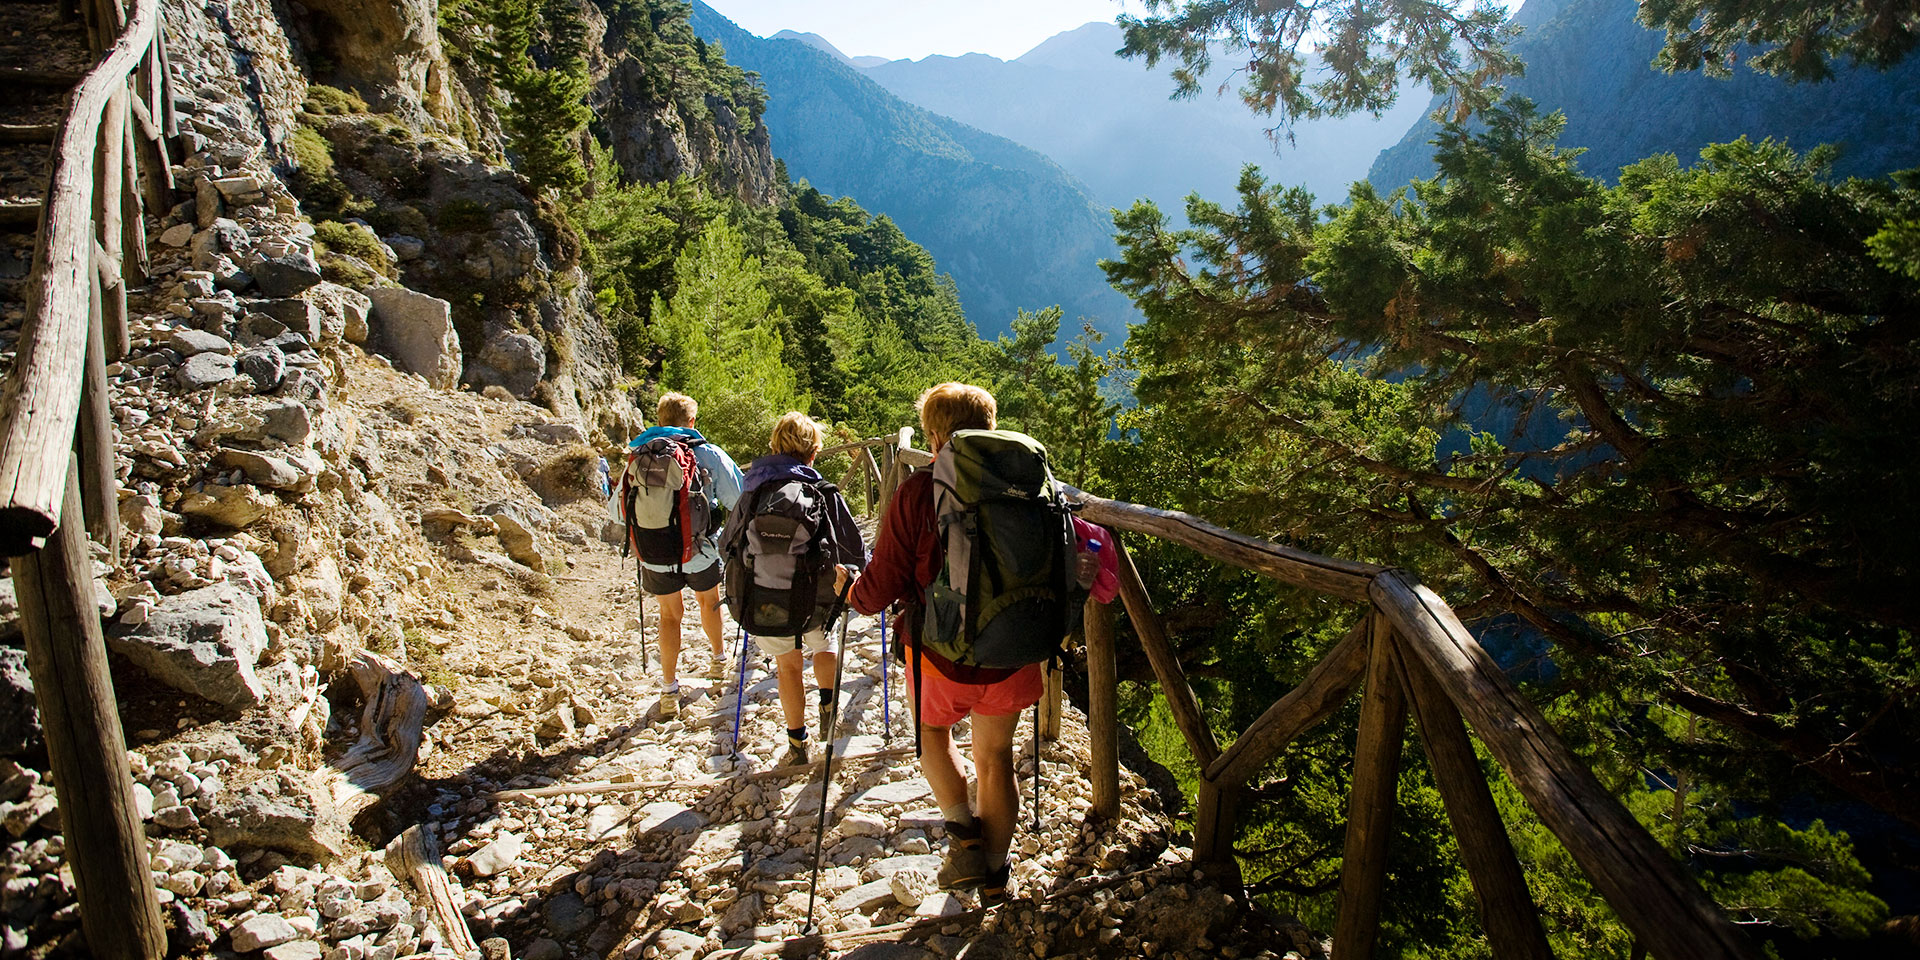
[334,651,453,820]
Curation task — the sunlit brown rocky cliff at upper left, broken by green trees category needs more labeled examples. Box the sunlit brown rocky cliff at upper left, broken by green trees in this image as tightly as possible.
[165,0,774,438]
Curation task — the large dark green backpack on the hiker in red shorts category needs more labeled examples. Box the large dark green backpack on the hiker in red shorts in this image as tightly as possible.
[916,430,1079,682]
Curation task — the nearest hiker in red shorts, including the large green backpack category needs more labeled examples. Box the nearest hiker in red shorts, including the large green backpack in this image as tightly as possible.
[837,382,1114,904]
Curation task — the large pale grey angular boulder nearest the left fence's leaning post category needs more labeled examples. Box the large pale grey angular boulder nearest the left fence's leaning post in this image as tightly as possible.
[108,584,267,708]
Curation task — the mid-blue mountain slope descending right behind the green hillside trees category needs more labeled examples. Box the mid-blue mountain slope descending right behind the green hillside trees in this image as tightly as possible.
[693,0,1139,340]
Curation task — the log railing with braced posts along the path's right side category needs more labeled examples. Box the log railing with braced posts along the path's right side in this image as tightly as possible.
[881,428,1759,960]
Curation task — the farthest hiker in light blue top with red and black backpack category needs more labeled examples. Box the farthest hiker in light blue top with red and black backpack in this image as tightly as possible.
[616,394,743,720]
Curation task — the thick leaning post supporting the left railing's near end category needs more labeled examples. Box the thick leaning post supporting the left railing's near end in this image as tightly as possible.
[12,460,167,960]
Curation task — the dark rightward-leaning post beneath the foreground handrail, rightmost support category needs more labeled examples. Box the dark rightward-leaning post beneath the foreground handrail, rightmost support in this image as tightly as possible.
[1394,643,1553,960]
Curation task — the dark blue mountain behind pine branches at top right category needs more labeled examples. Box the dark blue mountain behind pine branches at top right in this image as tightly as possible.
[1369,0,1920,190]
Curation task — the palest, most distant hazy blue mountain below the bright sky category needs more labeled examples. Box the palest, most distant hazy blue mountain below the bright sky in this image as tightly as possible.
[866,23,1423,213]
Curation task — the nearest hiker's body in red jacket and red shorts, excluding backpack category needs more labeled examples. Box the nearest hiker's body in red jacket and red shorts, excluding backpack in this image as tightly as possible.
[841,382,1114,902]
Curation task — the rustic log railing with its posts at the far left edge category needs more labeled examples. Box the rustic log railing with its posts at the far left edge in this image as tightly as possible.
[0,0,173,960]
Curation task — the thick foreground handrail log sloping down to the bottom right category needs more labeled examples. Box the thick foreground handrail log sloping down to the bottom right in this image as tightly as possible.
[1371,570,1759,960]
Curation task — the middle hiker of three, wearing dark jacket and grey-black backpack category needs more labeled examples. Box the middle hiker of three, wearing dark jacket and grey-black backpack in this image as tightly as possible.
[720,411,866,766]
